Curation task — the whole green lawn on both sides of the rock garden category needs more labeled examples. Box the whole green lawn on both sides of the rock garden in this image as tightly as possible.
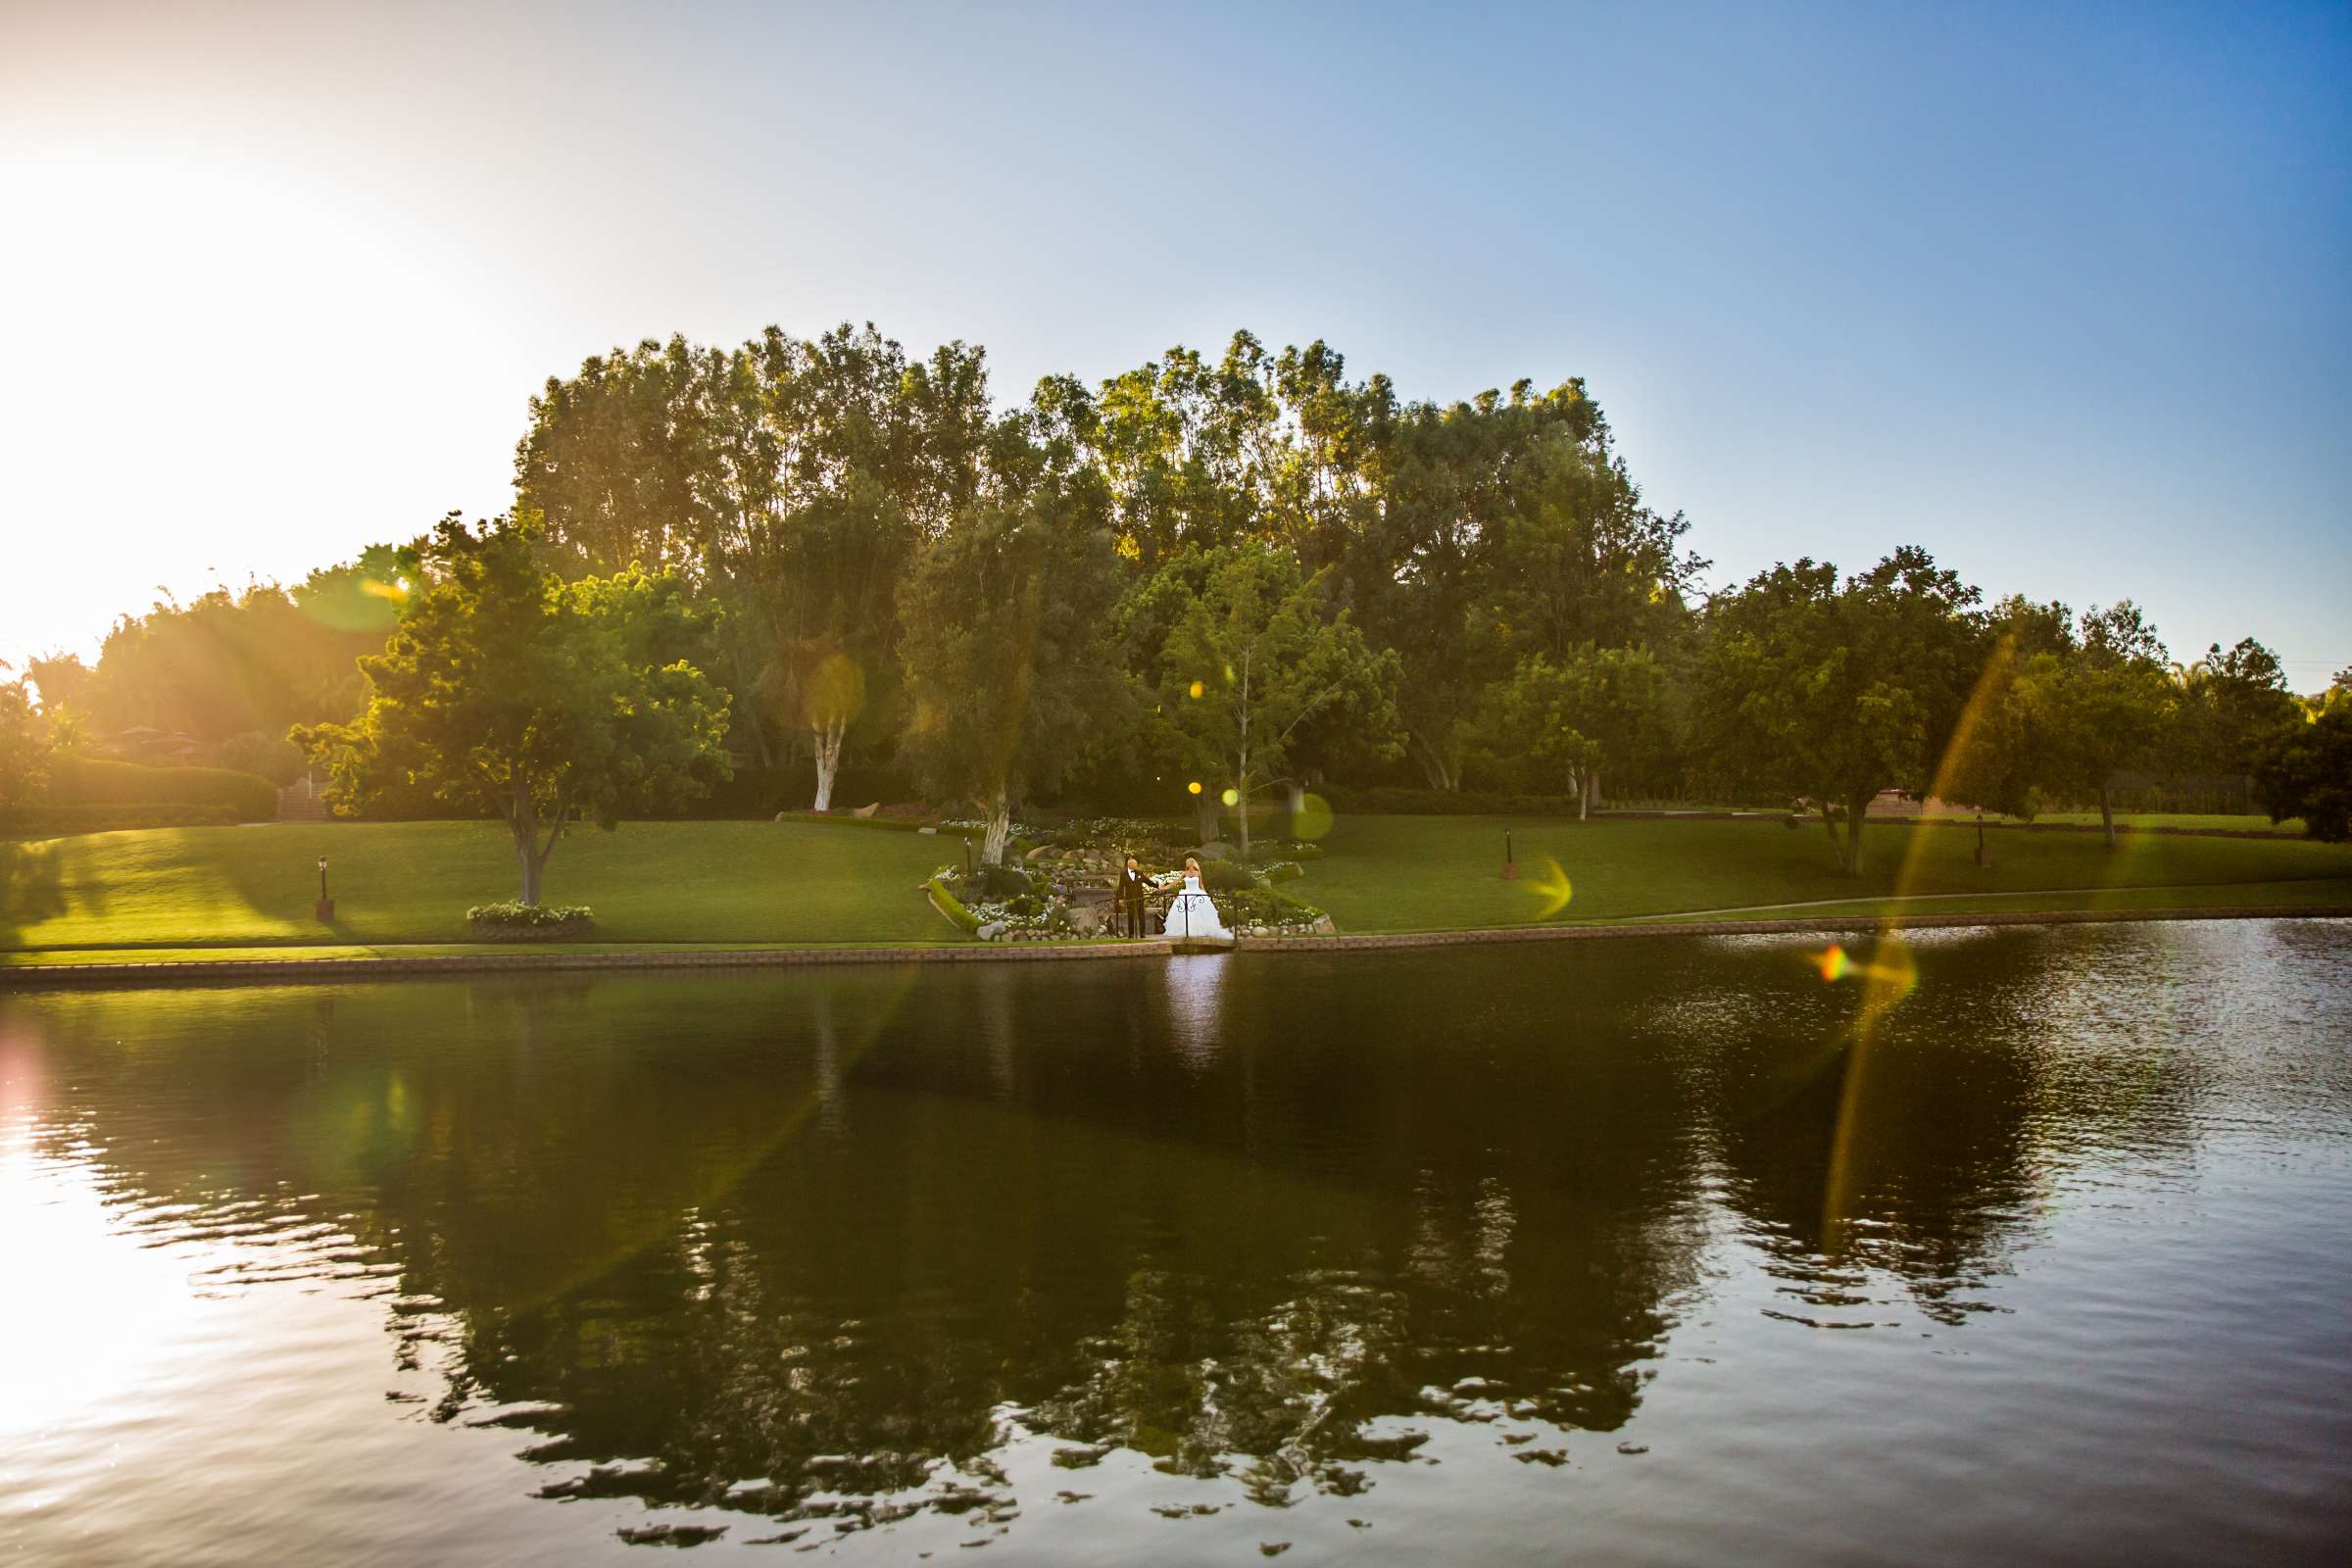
[0,815,2352,964]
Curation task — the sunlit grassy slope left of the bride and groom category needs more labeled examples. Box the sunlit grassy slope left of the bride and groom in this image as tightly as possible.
[0,823,959,950]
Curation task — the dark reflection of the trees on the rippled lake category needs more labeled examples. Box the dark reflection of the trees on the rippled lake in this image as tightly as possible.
[0,911,2352,1549]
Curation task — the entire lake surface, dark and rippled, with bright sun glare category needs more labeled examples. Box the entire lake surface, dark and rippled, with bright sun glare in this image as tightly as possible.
[0,921,2352,1566]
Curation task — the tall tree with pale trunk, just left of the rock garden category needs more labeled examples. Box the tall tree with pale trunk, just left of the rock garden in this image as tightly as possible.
[899,434,1129,865]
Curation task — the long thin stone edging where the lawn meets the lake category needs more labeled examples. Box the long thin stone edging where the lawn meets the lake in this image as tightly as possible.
[0,906,2352,990]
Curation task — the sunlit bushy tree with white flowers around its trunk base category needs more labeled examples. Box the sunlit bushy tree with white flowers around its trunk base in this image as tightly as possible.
[292,514,727,903]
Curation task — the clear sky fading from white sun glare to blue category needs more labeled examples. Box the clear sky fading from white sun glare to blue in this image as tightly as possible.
[0,0,2352,691]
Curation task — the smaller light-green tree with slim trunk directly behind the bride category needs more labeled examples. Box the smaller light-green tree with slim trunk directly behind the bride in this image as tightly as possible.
[1154,546,1399,854]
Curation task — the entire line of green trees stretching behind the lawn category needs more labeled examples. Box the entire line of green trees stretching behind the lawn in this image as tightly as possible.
[4,324,2352,886]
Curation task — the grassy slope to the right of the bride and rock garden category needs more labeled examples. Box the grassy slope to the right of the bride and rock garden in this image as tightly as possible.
[1292,815,2352,931]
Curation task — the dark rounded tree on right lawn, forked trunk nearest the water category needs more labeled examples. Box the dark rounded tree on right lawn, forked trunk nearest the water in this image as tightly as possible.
[1698,546,1985,877]
